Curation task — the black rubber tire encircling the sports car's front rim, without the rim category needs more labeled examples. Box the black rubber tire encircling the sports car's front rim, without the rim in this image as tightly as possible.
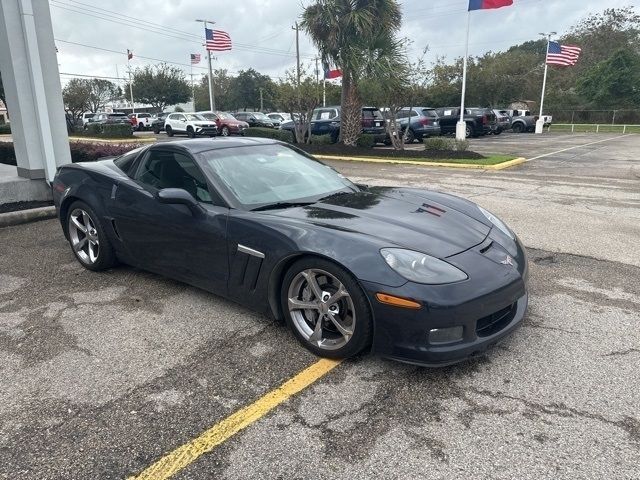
[280,257,373,358]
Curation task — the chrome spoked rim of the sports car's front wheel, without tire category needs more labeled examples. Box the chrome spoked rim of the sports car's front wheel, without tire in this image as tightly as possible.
[287,269,356,350]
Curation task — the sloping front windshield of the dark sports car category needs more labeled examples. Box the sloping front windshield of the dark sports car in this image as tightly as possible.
[200,144,358,210]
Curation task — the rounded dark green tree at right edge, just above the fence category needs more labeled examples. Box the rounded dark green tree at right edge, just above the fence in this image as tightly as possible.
[577,48,640,108]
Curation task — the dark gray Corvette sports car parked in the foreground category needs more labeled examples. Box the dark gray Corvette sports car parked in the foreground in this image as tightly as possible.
[53,138,528,365]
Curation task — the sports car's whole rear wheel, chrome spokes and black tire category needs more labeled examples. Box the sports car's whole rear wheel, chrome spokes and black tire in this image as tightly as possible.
[67,201,116,271]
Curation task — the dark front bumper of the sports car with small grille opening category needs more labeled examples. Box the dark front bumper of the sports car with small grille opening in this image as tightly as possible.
[363,236,529,367]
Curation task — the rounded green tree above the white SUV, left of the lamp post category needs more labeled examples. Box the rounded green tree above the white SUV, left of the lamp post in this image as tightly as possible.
[124,63,191,111]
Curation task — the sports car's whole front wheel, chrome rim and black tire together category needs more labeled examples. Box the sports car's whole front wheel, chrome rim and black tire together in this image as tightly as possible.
[281,258,373,358]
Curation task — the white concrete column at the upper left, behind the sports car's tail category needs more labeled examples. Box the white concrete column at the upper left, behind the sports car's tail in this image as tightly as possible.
[0,0,71,181]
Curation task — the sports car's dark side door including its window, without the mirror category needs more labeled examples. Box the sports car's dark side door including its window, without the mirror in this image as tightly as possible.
[110,147,229,295]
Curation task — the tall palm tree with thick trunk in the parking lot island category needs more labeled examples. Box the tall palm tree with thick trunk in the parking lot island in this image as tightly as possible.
[302,0,402,146]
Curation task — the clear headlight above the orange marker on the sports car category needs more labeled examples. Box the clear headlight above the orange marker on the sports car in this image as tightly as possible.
[380,248,468,285]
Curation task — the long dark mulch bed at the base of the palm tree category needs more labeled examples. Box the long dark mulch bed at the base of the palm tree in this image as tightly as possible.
[296,143,486,160]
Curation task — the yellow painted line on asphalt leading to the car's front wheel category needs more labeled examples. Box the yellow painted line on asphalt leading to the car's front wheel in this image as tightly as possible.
[129,359,340,480]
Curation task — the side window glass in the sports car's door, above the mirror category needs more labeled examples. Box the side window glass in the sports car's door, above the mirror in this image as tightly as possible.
[136,150,213,203]
